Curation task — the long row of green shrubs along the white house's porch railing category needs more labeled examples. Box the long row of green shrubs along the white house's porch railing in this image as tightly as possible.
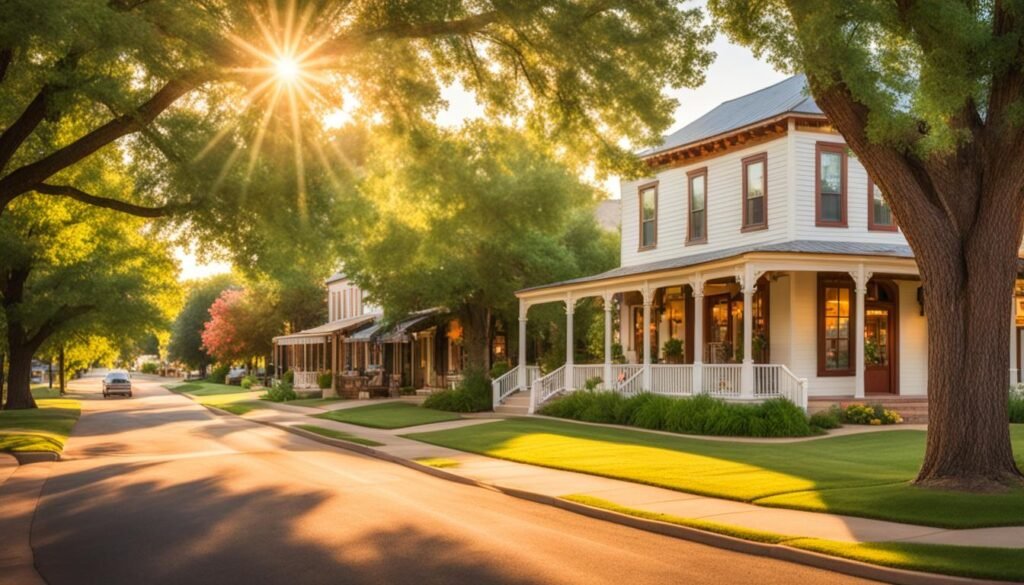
[541,390,816,436]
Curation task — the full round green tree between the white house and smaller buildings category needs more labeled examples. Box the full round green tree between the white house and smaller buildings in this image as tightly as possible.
[345,124,617,371]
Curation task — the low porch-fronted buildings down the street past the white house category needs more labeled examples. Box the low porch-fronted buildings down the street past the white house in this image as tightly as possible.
[273,274,507,398]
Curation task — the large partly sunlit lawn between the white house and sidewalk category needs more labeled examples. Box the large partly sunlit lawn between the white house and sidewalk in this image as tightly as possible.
[408,419,1024,528]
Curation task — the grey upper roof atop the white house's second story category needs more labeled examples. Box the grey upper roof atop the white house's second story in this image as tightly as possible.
[640,74,824,157]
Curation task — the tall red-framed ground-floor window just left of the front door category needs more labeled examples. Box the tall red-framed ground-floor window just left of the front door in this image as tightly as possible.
[818,276,855,376]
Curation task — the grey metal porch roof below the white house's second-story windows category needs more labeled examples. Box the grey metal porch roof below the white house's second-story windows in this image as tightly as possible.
[519,240,913,292]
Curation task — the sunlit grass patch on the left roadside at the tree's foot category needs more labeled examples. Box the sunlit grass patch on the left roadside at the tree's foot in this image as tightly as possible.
[0,399,81,453]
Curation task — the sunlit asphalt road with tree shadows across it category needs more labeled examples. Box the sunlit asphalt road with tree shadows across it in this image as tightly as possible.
[32,377,876,585]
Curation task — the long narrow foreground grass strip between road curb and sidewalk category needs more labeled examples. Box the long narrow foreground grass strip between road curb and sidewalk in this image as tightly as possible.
[562,495,1024,581]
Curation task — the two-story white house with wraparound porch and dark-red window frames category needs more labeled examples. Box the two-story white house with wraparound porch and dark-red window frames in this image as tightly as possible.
[495,76,1019,418]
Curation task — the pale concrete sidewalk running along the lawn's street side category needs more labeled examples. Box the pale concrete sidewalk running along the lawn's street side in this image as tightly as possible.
[239,409,1024,548]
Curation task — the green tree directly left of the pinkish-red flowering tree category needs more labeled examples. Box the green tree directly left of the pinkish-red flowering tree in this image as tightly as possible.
[167,275,237,377]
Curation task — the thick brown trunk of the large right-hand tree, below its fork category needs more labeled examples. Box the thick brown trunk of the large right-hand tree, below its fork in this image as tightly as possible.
[916,214,1021,490]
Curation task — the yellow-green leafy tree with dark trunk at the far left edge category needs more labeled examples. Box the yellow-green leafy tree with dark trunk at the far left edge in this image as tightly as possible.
[0,197,179,409]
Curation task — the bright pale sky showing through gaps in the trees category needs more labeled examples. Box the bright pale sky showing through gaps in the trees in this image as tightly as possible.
[175,35,786,281]
